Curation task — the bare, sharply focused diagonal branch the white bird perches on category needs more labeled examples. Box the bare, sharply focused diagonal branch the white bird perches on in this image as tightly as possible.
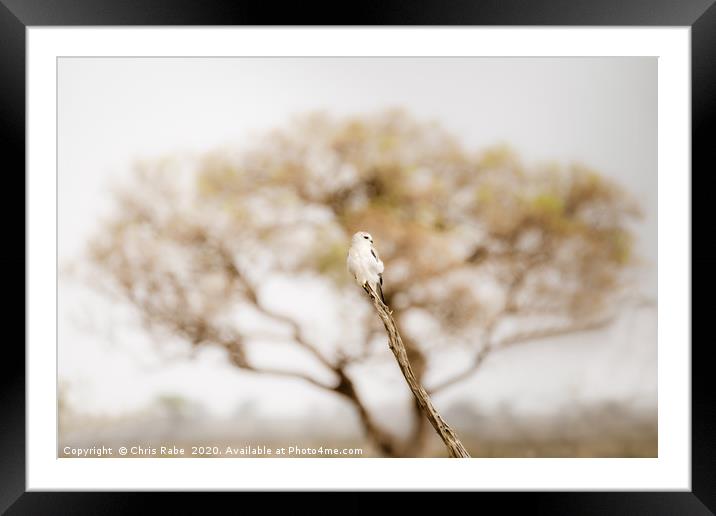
[366,287,470,457]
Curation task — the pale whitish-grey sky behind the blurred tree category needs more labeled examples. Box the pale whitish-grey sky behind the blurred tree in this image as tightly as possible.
[58,58,657,424]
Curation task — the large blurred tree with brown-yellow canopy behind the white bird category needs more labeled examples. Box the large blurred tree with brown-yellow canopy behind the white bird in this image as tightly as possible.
[90,111,639,456]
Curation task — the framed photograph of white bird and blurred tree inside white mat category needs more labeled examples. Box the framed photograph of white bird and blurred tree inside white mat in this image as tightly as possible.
[56,56,656,464]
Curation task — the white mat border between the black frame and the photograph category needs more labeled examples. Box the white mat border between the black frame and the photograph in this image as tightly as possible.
[28,28,690,489]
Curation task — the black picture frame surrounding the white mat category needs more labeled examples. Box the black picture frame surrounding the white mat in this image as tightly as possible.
[0,0,716,515]
